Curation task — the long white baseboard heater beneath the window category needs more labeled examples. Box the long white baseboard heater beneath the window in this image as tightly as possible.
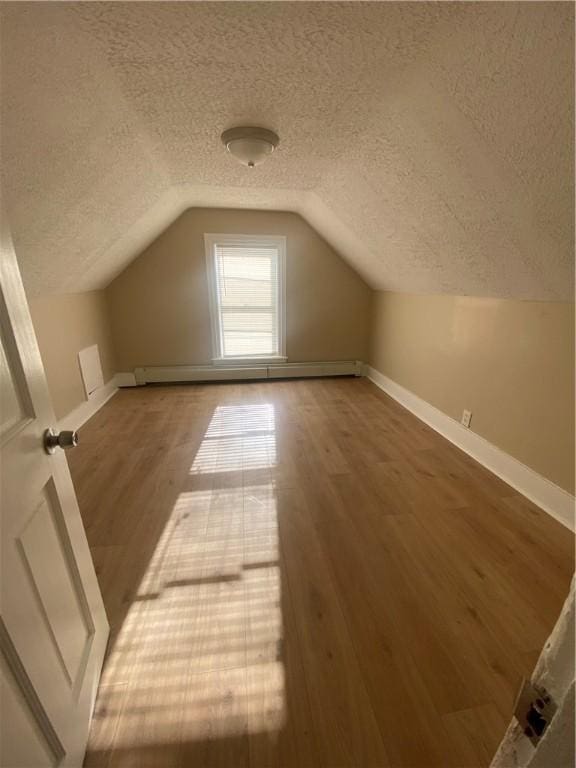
[132,360,364,386]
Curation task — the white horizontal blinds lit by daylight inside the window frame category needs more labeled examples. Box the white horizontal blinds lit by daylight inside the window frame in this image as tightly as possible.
[213,242,281,358]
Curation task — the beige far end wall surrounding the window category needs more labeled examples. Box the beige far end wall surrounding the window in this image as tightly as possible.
[106,208,372,371]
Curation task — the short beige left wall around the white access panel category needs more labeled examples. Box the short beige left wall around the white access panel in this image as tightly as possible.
[30,291,115,419]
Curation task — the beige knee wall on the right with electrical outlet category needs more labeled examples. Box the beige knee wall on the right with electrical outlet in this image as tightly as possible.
[370,292,574,493]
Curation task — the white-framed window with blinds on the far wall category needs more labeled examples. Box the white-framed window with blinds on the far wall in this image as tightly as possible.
[205,235,286,362]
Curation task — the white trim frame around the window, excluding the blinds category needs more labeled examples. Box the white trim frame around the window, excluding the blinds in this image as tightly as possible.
[204,233,288,365]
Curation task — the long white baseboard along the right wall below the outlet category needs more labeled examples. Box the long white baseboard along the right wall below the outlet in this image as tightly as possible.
[366,366,575,531]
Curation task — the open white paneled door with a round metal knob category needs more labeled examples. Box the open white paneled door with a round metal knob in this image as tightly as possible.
[0,217,108,768]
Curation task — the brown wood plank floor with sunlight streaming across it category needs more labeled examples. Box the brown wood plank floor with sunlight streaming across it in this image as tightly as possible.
[69,379,574,768]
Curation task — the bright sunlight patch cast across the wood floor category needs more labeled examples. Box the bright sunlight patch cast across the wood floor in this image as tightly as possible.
[95,404,285,748]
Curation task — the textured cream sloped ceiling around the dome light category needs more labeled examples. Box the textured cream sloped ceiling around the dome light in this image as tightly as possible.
[1,2,574,300]
